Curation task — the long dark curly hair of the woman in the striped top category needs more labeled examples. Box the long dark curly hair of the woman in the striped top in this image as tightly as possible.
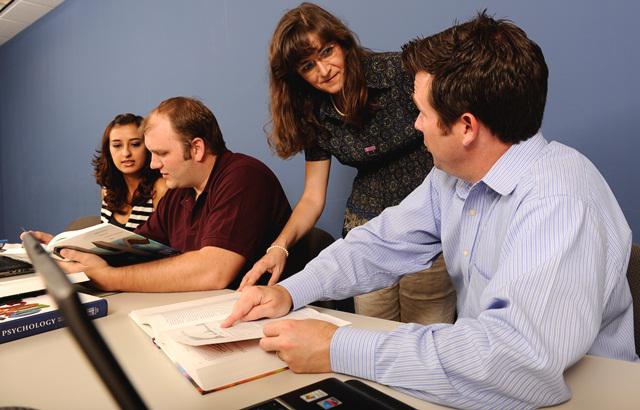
[91,113,160,212]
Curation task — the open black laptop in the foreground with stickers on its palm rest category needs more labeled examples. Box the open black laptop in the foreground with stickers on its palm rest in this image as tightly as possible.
[23,234,413,410]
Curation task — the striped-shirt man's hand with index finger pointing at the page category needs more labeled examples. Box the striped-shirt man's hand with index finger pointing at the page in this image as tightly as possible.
[220,285,293,327]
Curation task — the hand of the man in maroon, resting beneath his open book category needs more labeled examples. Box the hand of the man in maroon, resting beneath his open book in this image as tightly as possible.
[58,249,118,290]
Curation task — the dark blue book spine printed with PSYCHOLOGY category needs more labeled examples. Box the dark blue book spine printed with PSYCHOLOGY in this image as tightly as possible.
[0,299,107,344]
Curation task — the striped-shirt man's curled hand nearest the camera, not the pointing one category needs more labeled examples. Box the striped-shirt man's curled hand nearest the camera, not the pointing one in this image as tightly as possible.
[260,319,337,373]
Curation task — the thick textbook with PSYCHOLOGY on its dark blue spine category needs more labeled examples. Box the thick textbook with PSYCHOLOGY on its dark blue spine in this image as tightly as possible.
[0,293,108,343]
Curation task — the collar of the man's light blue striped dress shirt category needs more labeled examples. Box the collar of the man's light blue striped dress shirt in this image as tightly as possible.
[482,132,548,195]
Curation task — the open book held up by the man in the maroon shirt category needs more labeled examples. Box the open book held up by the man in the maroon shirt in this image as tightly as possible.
[47,223,179,266]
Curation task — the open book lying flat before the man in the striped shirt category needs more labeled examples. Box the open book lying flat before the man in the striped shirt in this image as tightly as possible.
[129,292,350,393]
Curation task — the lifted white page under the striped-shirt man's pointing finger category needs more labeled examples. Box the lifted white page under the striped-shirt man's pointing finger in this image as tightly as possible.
[165,308,350,346]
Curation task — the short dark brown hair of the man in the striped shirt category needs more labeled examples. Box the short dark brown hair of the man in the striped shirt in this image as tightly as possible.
[402,11,549,143]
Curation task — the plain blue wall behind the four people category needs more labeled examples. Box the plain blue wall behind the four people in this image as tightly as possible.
[0,0,640,241]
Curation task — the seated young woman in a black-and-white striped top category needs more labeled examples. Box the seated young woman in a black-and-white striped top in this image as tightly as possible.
[93,113,167,231]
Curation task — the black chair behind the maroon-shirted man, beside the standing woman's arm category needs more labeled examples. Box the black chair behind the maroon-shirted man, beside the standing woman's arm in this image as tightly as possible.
[281,227,354,313]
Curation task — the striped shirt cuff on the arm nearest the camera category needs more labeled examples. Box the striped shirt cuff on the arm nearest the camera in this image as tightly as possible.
[329,326,381,380]
